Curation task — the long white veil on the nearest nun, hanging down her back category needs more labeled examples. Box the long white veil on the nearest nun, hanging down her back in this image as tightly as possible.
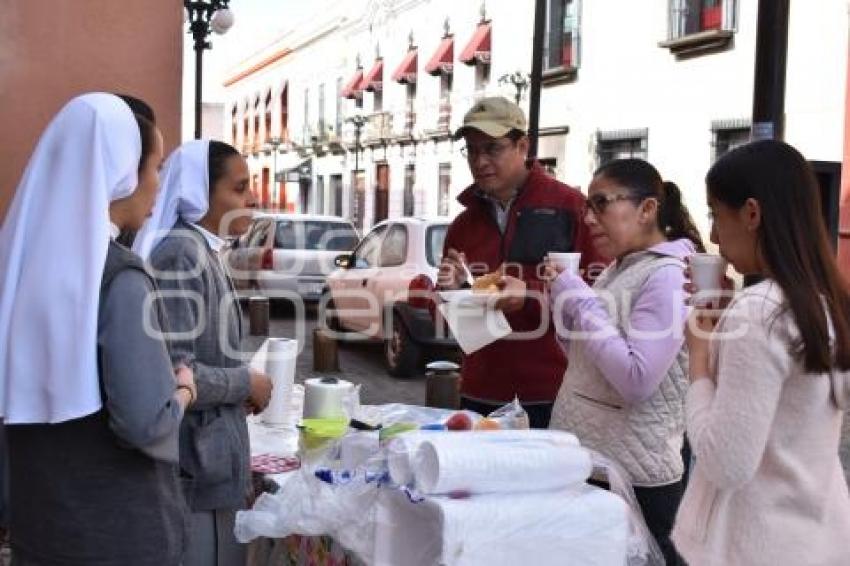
[0,93,142,423]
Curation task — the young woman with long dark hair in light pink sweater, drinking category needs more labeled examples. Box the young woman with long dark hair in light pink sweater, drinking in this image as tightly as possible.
[673,140,850,566]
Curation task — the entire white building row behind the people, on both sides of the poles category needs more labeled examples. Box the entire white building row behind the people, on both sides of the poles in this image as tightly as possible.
[224,0,848,242]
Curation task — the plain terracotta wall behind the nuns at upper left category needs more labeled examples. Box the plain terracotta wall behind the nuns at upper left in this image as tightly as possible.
[0,0,184,222]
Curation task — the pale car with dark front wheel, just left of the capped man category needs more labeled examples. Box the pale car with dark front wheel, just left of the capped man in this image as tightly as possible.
[324,217,458,377]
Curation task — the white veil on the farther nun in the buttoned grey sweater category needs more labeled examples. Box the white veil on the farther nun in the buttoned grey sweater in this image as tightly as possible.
[133,140,210,260]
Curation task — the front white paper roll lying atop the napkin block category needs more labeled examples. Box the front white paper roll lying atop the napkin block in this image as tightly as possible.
[411,430,593,495]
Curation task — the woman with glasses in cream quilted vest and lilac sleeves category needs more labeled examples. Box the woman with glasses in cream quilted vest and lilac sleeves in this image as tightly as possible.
[546,159,703,565]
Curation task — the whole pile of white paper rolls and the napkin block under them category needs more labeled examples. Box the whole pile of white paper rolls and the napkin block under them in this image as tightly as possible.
[374,430,629,566]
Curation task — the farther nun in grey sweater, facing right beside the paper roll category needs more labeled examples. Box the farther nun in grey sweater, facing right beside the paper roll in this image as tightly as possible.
[134,140,271,566]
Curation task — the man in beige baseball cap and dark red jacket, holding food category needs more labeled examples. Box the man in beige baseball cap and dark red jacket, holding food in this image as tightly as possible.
[438,97,607,428]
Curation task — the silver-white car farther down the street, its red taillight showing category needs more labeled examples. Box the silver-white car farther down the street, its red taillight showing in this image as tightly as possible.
[222,213,359,301]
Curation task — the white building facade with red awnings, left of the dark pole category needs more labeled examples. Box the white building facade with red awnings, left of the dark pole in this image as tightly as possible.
[224,0,533,232]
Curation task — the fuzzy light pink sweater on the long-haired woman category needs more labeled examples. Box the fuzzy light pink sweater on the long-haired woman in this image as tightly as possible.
[672,280,850,566]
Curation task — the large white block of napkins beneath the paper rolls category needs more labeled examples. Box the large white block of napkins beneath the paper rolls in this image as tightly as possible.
[374,484,629,566]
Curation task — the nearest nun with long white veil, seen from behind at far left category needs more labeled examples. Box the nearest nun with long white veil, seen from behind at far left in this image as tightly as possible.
[0,93,195,566]
